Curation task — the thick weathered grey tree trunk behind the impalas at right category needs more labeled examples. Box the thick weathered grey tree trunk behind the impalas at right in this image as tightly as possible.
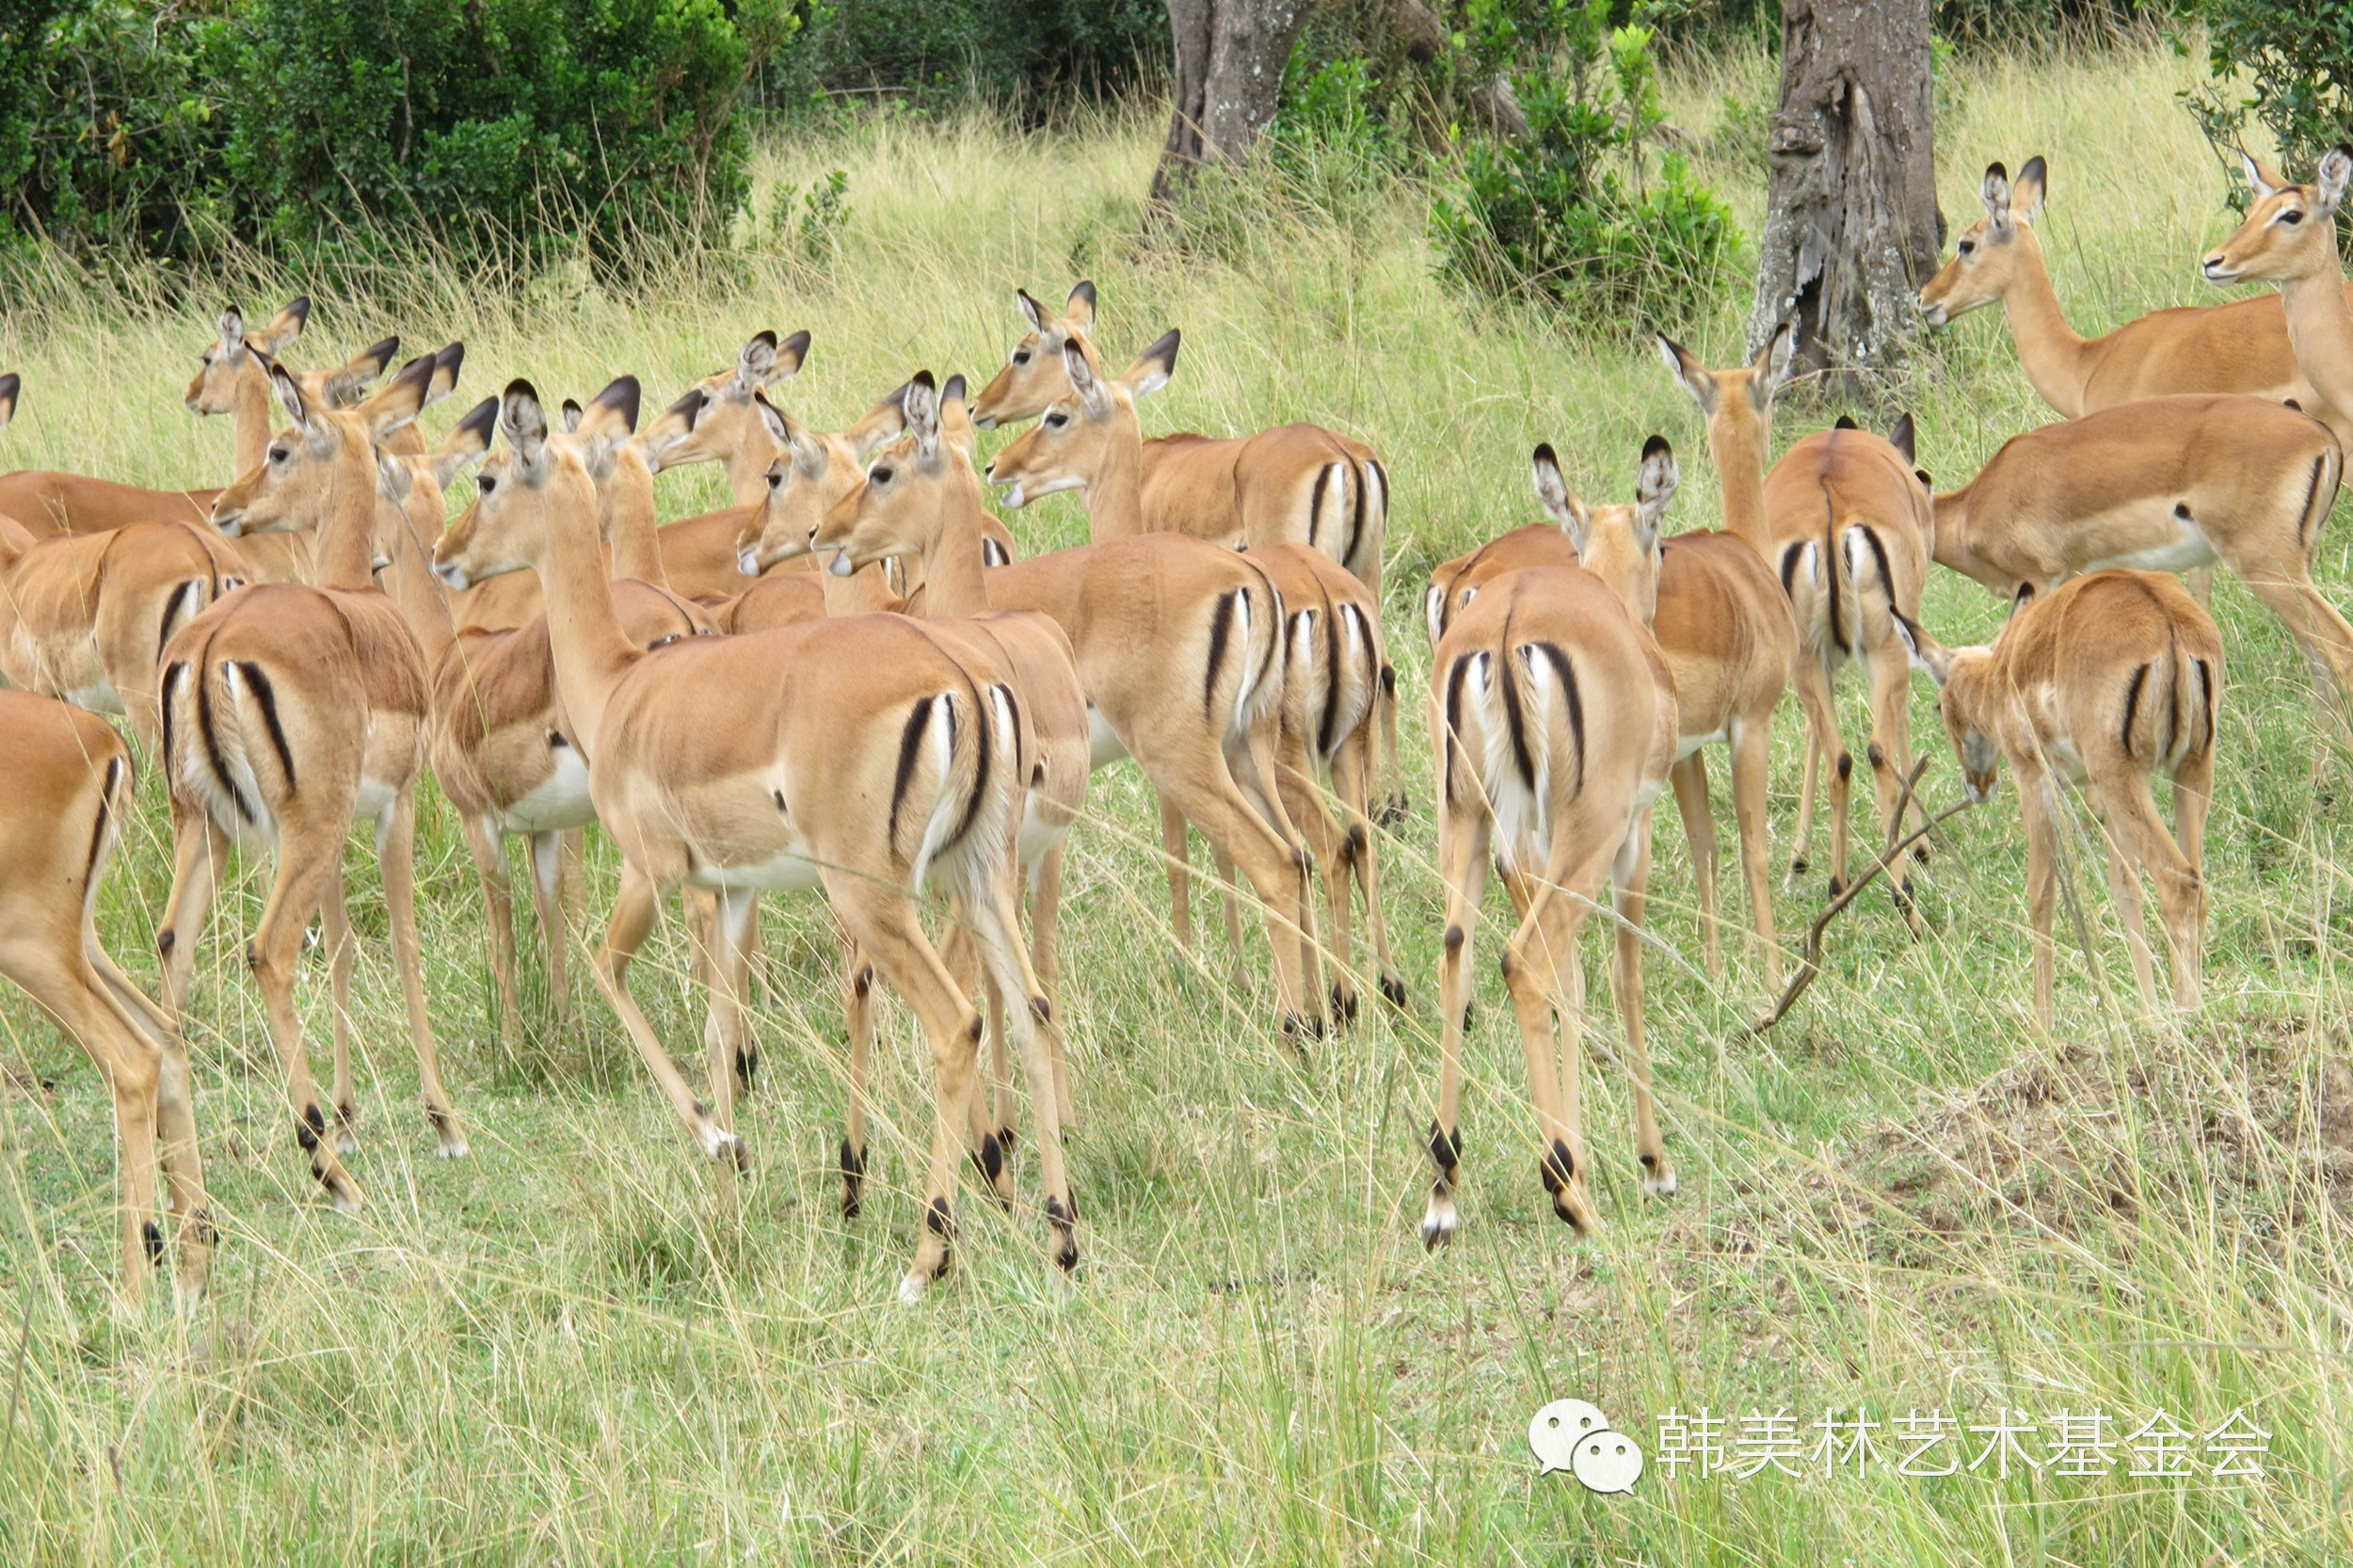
[1749,0,1944,389]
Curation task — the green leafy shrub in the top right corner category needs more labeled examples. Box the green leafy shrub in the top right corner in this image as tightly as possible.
[2177,0,2353,233]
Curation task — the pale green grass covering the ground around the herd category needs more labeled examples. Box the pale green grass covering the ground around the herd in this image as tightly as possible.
[0,27,2353,1563]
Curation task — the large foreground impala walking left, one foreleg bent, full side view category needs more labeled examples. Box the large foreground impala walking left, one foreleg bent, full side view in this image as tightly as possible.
[436,381,1078,1302]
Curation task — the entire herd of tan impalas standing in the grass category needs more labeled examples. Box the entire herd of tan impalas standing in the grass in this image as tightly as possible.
[0,149,2353,1300]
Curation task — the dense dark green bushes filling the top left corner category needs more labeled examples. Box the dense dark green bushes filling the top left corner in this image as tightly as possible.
[0,0,798,271]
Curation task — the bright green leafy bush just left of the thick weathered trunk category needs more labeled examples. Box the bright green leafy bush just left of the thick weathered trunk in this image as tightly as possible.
[1433,0,1735,313]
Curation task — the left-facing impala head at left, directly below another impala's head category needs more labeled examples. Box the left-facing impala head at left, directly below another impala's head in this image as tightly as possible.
[212,353,442,539]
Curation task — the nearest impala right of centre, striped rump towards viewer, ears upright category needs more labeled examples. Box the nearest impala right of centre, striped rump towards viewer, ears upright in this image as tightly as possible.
[1421,436,1678,1248]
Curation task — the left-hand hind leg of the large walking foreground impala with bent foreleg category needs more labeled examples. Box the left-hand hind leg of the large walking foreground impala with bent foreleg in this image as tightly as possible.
[824,869,988,1306]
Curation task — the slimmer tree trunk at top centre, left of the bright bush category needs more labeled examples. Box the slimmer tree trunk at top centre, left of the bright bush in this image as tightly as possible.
[1153,0,1306,207]
